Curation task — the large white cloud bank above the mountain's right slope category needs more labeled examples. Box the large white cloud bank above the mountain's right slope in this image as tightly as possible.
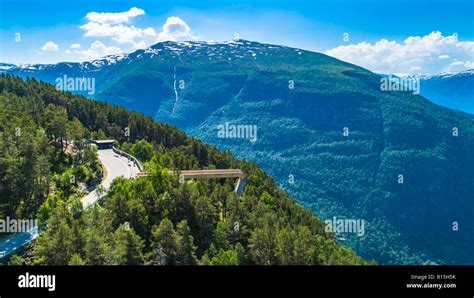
[325,31,474,74]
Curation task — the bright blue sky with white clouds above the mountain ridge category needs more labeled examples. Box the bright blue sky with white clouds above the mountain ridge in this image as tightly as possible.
[0,0,474,74]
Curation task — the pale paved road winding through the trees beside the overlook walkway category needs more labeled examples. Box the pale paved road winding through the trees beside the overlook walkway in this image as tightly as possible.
[0,149,140,259]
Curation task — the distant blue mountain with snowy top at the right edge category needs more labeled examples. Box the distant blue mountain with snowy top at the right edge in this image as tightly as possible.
[405,69,474,114]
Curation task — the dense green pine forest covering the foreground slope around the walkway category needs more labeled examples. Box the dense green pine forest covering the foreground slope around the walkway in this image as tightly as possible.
[0,75,372,265]
